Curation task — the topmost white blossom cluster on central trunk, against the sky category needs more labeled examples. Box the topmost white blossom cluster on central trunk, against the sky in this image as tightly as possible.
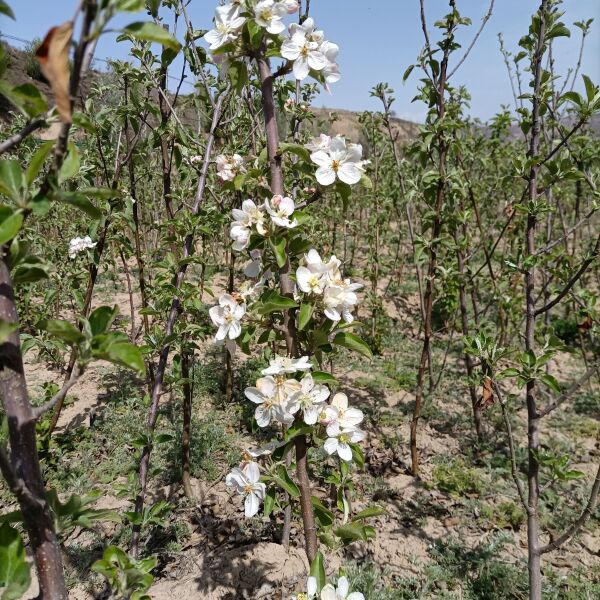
[204,0,341,85]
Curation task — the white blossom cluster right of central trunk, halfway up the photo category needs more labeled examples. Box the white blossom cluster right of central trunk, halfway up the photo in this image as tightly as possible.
[296,248,363,323]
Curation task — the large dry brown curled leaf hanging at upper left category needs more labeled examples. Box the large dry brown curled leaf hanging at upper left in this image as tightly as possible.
[35,21,73,123]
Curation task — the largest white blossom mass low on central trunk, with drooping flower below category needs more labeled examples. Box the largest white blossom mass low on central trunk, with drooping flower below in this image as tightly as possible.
[226,356,365,517]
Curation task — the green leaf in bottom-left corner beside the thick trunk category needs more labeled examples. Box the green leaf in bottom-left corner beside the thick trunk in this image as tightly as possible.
[0,523,31,600]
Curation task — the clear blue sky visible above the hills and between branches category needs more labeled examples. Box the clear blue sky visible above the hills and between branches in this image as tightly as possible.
[0,0,600,121]
